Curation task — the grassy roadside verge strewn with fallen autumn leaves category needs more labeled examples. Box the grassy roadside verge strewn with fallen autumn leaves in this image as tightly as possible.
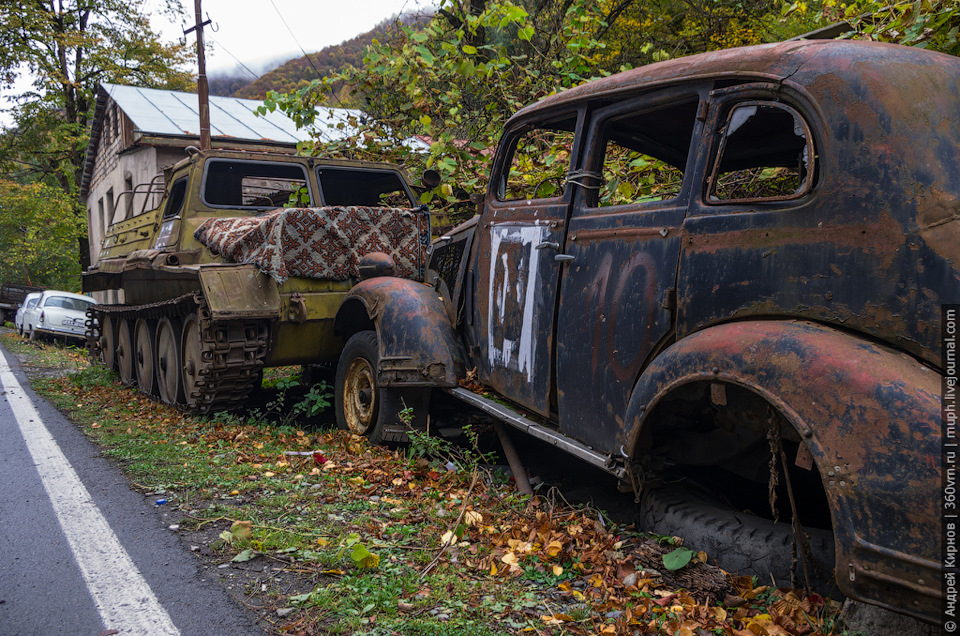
[0,333,852,636]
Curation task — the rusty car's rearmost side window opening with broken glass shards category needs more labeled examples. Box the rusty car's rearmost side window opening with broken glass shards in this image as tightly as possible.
[707,102,814,203]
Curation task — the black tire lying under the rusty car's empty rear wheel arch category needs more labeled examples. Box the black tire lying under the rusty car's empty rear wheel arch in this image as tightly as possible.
[638,485,842,598]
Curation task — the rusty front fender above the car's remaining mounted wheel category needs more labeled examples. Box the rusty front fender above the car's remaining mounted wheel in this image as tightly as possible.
[334,276,466,387]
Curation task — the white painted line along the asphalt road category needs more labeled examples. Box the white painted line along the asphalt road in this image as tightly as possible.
[0,352,180,636]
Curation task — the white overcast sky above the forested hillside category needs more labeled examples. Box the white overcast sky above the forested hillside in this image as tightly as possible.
[161,0,433,75]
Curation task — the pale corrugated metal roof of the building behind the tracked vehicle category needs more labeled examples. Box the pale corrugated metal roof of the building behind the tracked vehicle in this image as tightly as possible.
[101,84,363,144]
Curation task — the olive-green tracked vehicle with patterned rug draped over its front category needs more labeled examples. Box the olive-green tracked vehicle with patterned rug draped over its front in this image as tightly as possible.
[83,150,430,412]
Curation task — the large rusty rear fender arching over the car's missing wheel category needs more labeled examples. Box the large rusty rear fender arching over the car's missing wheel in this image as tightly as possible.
[624,321,941,620]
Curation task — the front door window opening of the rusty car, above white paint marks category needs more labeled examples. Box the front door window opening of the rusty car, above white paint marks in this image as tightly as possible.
[497,119,577,201]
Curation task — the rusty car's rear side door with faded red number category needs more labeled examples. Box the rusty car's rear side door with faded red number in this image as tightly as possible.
[556,86,707,452]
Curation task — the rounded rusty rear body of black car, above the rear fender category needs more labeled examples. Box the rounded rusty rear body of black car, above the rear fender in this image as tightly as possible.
[664,43,960,366]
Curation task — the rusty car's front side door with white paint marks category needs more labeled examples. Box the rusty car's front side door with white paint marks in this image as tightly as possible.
[467,112,583,415]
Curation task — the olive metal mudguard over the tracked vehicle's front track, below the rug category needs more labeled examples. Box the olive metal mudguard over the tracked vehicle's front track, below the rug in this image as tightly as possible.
[199,265,280,318]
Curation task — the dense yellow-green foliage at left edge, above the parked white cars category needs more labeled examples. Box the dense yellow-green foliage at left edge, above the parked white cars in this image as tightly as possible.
[0,179,83,291]
